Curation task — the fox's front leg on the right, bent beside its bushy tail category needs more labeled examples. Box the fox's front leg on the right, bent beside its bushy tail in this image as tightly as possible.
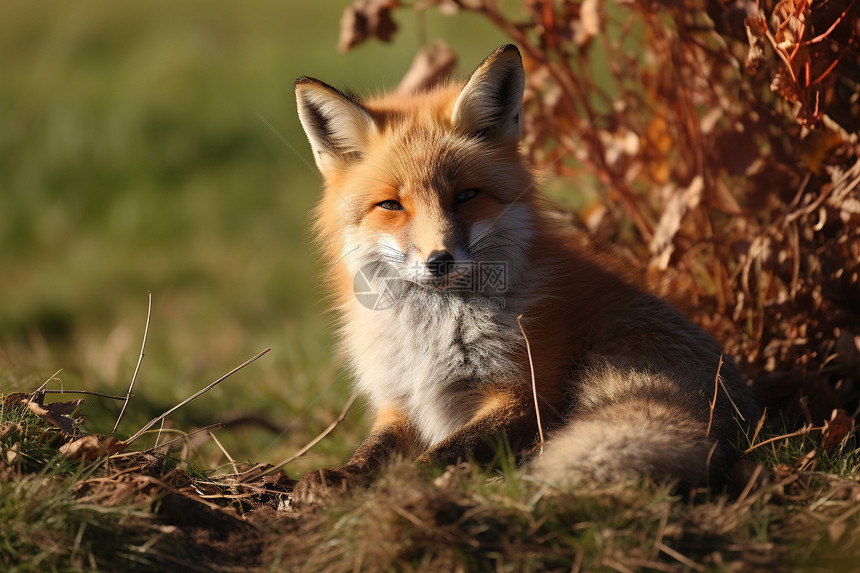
[416,388,538,465]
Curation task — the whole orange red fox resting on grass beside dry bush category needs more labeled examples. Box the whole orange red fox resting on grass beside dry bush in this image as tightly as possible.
[293,45,758,503]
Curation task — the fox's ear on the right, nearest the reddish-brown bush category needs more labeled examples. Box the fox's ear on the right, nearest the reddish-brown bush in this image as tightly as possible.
[451,44,526,140]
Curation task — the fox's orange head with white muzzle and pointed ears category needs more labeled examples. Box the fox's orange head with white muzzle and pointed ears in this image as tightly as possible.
[295,45,536,302]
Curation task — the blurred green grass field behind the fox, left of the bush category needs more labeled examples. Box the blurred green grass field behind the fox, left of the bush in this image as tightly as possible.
[0,0,505,474]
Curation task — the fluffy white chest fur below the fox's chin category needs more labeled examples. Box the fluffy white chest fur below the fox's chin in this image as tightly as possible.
[343,288,522,445]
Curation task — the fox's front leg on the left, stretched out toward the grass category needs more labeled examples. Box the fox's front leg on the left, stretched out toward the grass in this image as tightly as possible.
[292,408,417,504]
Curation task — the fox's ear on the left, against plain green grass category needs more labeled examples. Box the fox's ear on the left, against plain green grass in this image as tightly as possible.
[296,77,376,177]
